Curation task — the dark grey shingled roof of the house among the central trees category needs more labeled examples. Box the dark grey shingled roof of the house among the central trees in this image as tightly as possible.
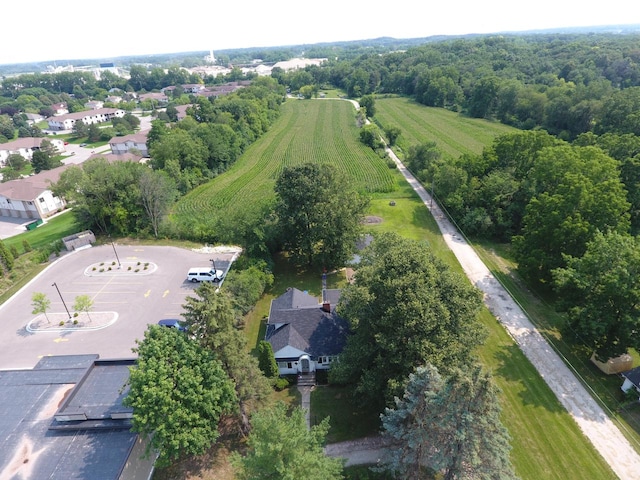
[265,288,349,357]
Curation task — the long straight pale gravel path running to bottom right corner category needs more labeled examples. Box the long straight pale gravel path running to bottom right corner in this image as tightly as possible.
[387,144,640,480]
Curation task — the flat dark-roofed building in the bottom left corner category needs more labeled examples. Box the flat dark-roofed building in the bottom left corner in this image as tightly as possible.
[0,355,156,480]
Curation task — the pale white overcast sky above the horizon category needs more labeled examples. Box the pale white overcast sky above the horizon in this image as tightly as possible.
[0,0,640,64]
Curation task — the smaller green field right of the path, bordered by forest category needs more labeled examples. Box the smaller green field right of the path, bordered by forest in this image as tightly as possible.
[375,97,515,158]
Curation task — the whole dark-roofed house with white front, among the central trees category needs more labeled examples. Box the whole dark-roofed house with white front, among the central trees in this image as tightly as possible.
[265,288,349,381]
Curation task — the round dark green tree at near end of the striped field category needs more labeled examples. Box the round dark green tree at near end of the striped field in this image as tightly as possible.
[275,163,368,268]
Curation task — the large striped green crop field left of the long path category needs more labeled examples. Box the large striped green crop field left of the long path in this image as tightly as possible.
[173,100,396,223]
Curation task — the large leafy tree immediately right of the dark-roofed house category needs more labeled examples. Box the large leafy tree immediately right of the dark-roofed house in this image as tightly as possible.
[329,233,485,405]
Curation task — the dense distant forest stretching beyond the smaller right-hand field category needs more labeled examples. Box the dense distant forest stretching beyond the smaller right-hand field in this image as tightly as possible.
[282,34,640,139]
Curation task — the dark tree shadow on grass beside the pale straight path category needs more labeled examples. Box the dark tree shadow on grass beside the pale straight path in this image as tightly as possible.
[494,345,565,413]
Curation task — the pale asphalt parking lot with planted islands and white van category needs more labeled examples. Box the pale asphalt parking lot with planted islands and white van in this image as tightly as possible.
[0,245,237,369]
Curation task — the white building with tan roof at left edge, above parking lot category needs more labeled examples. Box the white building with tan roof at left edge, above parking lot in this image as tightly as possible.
[0,165,71,220]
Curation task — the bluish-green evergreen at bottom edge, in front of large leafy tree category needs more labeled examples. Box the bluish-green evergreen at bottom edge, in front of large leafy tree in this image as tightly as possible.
[381,365,517,480]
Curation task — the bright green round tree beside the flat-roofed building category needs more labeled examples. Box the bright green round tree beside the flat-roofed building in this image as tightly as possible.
[123,325,236,466]
